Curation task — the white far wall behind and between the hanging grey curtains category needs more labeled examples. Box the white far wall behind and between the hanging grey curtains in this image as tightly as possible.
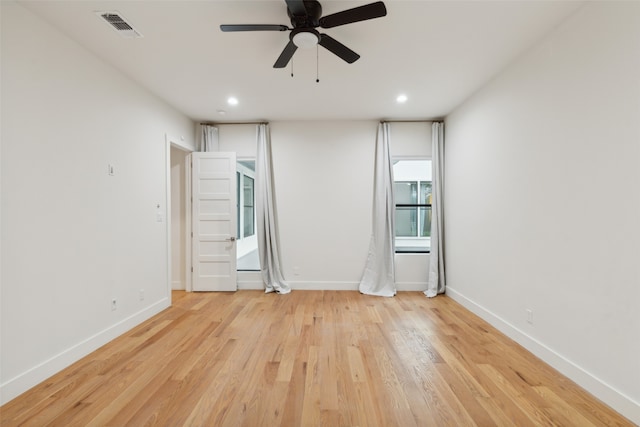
[218,121,431,290]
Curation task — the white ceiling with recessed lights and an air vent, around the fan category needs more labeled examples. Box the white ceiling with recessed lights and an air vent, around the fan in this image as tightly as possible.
[21,0,582,121]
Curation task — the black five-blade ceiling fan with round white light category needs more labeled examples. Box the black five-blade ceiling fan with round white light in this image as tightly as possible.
[220,0,387,68]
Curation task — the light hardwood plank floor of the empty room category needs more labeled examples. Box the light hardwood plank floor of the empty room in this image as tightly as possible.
[0,291,632,427]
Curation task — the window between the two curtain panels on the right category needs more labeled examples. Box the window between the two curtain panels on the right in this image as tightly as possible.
[393,160,431,253]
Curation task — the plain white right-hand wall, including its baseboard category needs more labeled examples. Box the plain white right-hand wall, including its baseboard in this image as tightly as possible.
[445,2,640,423]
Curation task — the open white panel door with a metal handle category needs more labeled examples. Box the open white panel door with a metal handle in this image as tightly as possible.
[191,152,238,291]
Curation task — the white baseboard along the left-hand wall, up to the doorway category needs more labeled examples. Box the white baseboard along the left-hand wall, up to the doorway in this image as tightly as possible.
[0,297,171,405]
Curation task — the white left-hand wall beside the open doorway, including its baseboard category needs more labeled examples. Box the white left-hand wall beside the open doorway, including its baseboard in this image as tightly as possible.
[0,1,195,402]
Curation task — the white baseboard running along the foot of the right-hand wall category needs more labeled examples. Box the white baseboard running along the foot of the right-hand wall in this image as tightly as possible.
[446,286,640,425]
